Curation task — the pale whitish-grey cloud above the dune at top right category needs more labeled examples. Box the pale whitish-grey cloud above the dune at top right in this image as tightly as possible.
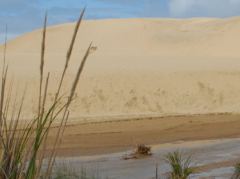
[169,0,240,17]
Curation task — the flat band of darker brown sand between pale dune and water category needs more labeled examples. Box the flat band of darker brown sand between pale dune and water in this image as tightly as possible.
[47,114,240,156]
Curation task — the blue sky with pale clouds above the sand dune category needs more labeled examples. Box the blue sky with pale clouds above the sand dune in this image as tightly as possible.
[0,0,240,42]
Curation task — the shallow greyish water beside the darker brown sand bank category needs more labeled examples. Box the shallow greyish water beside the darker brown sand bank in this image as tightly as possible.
[53,139,240,179]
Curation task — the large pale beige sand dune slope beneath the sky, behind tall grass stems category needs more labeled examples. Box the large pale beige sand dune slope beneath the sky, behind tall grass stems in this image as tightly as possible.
[0,18,240,119]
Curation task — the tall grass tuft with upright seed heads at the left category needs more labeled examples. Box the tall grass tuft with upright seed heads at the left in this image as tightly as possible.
[0,10,91,179]
